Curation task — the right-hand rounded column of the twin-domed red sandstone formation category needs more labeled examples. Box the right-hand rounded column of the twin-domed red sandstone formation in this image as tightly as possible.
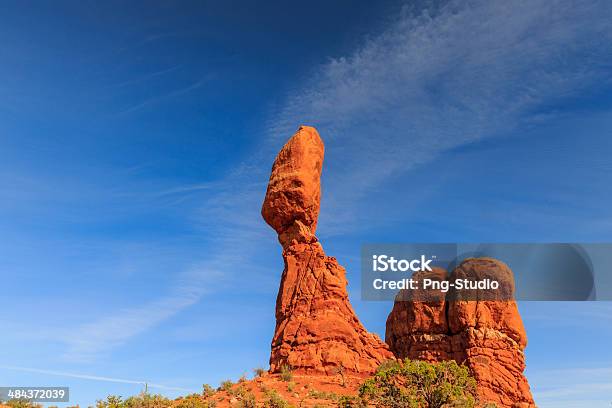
[448,258,533,407]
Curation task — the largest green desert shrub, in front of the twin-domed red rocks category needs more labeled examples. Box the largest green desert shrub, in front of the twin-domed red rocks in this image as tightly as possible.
[359,359,476,408]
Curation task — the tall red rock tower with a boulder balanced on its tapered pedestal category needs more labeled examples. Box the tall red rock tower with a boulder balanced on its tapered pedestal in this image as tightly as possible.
[261,126,394,374]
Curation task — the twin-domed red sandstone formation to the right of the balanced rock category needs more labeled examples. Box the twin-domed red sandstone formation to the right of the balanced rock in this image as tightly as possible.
[386,258,535,408]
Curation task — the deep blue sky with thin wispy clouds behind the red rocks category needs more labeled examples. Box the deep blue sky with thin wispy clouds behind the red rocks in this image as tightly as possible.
[0,0,612,407]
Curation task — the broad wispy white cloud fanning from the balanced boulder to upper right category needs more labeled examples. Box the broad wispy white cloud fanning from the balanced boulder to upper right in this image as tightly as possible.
[268,0,612,233]
